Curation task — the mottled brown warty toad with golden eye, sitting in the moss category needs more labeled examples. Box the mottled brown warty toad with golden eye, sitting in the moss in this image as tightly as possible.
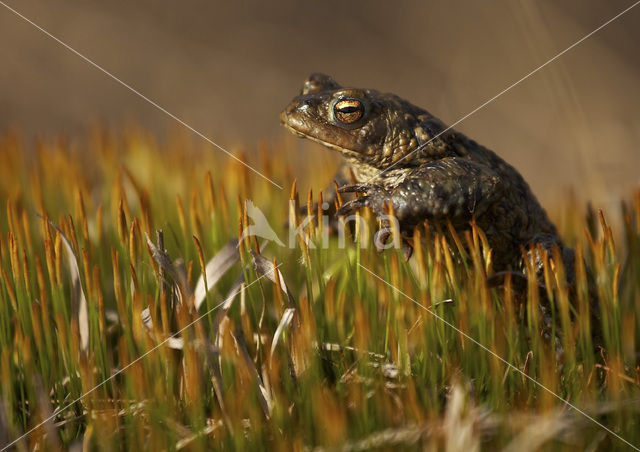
[281,74,573,273]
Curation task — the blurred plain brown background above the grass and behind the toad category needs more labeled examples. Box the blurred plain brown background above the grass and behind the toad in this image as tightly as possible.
[0,0,640,207]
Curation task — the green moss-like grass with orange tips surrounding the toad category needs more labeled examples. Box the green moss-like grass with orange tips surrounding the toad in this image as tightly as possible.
[0,128,640,450]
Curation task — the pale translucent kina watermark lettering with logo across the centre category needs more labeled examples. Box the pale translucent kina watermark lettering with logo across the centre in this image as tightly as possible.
[240,199,402,251]
